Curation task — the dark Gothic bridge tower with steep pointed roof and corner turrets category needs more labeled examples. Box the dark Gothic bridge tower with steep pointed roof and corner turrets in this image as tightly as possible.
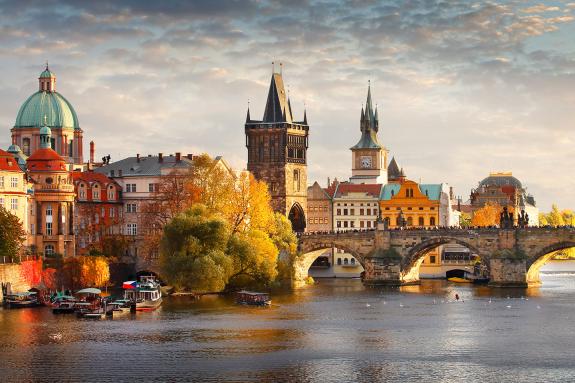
[245,71,309,232]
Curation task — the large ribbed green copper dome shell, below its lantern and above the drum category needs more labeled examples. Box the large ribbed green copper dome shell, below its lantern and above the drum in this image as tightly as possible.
[14,91,80,129]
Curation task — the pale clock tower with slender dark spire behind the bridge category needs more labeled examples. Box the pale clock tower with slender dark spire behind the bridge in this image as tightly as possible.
[349,86,388,184]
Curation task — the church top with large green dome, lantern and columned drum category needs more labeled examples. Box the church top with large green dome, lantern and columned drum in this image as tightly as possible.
[11,64,83,165]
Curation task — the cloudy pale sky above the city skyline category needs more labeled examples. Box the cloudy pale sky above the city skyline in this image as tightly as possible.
[0,0,575,211]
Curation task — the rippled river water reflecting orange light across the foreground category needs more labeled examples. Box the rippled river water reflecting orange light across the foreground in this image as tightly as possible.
[0,262,575,383]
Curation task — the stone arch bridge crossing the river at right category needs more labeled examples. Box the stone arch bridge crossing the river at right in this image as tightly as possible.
[294,224,575,287]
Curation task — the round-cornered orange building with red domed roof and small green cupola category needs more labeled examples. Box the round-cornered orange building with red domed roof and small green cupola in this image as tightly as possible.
[26,126,75,256]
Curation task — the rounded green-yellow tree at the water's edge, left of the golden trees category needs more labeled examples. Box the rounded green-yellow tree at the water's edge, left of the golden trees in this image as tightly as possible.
[160,204,232,292]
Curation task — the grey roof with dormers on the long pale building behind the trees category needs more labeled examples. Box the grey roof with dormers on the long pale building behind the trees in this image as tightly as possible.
[94,156,192,177]
